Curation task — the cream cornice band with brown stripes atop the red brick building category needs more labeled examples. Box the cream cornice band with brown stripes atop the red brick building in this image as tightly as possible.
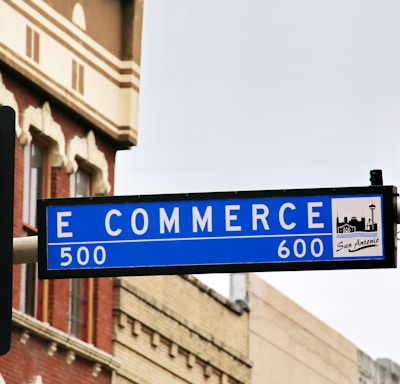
[0,0,140,149]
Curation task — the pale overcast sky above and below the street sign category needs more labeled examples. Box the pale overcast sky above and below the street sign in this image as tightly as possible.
[116,0,400,364]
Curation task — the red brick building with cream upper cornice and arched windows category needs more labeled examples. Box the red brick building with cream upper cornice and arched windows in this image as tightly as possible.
[0,0,143,384]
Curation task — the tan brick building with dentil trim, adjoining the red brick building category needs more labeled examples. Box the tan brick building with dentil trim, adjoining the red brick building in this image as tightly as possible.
[113,276,251,384]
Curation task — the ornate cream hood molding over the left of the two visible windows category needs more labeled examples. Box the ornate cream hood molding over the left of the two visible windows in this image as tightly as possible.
[20,101,67,167]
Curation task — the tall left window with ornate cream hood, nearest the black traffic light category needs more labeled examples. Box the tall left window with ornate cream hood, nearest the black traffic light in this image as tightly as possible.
[19,102,66,320]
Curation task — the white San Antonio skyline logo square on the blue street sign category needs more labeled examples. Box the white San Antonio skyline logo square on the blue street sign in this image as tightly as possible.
[332,196,382,257]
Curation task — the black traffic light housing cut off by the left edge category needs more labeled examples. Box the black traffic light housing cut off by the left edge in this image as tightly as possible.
[0,106,15,355]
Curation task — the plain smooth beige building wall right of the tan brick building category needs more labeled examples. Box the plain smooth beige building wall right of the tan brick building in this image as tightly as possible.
[246,274,359,384]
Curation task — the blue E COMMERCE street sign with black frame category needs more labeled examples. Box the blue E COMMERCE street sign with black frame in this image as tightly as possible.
[38,186,396,278]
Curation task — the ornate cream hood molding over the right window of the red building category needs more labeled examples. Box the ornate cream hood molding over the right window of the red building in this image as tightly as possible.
[67,131,111,195]
